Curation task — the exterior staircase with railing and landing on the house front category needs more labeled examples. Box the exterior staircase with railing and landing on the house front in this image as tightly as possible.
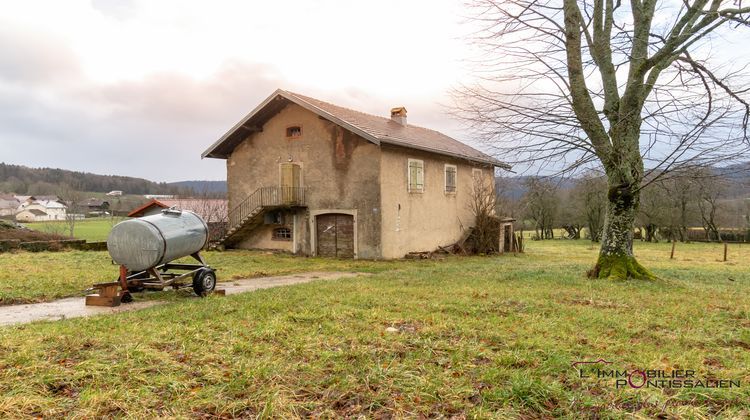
[219,187,306,247]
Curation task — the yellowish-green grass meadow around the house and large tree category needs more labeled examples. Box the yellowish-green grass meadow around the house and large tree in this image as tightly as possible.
[0,241,750,418]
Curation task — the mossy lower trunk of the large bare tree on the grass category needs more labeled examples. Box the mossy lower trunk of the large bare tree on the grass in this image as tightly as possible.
[589,177,656,280]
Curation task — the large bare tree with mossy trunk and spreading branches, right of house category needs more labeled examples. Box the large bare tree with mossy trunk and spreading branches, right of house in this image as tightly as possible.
[456,0,750,279]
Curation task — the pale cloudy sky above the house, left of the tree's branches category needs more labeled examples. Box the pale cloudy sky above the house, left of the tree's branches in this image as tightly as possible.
[0,0,482,181]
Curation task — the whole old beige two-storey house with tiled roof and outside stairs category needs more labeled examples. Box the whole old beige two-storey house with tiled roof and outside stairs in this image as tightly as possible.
[203,90,508,258]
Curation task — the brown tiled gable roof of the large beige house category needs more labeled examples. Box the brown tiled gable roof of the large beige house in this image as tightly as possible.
[203,89,510,169]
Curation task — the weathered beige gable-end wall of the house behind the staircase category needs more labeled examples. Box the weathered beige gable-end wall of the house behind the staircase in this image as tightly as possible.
[227,104,381,258]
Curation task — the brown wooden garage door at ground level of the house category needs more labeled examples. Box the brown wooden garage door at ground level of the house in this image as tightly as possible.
[315,213,354,258]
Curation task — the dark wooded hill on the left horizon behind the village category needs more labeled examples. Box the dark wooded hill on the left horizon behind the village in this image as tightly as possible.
[0,163,184,195]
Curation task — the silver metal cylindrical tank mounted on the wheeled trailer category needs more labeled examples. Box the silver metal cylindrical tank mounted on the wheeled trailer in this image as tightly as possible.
[107,209,208,271]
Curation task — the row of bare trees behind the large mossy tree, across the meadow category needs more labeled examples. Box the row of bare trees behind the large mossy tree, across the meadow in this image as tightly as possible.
[497,168,750,242]
